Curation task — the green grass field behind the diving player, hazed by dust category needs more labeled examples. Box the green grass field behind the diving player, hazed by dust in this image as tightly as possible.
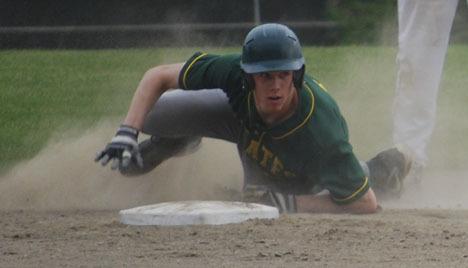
[0,46,468,171]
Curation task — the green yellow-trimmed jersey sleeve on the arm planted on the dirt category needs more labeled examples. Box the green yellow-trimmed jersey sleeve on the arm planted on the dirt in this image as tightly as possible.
[306,81,369,204]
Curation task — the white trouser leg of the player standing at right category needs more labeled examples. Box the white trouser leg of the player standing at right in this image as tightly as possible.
[393,0,458,184]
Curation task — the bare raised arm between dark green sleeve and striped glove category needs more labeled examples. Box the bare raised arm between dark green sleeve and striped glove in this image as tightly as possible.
[124,63,184,130]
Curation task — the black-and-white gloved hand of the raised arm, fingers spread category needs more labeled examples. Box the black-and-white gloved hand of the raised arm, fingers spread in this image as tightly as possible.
[94,125,143,170]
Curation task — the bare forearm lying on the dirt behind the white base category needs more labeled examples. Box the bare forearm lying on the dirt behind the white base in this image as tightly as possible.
[296,188,379,214]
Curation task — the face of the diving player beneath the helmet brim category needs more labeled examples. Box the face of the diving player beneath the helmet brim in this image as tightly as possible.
[253,71,298,124]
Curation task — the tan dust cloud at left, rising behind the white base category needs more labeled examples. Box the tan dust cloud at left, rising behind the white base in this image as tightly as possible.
[0,123,242,210]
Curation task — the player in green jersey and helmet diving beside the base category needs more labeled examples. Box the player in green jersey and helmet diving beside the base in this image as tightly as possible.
[96,24,406,213]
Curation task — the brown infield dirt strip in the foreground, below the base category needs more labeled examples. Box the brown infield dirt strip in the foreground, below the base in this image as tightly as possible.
[0,209,468,267]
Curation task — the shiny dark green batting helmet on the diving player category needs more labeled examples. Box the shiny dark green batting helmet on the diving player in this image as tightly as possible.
[240,23,305,89]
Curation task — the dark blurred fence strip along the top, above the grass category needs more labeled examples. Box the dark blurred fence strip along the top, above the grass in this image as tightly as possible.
[0,0,468,49]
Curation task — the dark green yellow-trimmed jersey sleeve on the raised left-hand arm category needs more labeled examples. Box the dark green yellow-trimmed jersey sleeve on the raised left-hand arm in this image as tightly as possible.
[179,52,241,95]
